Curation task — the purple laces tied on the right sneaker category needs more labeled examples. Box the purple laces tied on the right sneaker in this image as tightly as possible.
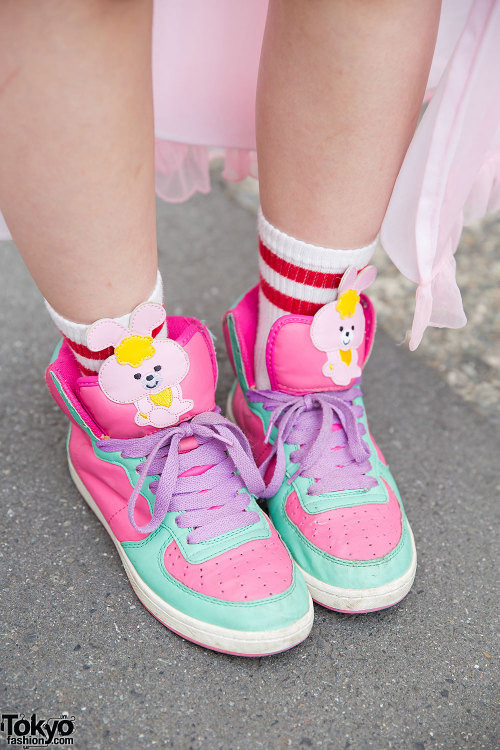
[247,387,377,497]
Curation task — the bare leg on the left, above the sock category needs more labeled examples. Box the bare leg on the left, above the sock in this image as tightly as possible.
[0,0,157,323]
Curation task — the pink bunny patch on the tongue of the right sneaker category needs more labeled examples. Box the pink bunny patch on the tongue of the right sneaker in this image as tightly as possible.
[311,266,377,386]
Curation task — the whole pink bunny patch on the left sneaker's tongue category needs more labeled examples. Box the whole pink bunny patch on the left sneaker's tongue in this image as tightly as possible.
[87,302,194,427]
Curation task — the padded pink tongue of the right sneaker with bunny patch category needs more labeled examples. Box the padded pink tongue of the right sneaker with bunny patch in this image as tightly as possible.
[266,294,375,395]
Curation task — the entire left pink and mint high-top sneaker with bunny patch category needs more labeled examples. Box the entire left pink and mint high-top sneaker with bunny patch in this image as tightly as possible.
[47,304,313,656]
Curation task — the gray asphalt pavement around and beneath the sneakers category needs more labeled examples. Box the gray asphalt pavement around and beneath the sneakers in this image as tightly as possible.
[0,182,500,750]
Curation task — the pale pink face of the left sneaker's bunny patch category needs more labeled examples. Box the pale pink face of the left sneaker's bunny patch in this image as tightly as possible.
[99,339,189,404]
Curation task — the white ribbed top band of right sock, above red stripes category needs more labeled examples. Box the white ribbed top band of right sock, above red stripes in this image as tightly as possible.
[258,209,378,274]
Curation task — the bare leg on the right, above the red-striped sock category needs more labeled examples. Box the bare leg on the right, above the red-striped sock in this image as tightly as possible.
[257,0,441,248]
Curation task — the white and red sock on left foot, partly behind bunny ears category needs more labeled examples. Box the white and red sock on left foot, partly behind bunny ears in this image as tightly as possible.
[45,271,164,375]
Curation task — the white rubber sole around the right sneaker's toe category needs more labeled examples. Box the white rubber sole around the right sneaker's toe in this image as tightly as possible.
[226,391,417,614]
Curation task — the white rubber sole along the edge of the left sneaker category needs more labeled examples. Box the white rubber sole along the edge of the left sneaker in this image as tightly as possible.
[68,453,314,656]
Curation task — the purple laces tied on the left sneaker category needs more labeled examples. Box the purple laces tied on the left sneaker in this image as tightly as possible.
[98,412,264,544]
